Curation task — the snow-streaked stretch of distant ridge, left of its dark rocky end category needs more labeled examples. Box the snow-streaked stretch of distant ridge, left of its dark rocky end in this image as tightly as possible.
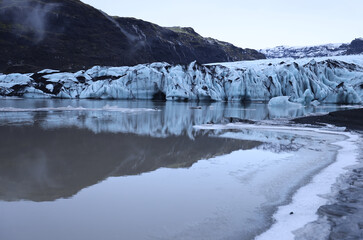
[260,43,349,58]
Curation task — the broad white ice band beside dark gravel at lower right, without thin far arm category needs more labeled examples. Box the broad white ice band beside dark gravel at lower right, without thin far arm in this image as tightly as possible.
[255,129,360,240]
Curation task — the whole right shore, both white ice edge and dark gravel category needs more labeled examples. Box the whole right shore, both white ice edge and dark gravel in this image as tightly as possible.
[199,108,363,240]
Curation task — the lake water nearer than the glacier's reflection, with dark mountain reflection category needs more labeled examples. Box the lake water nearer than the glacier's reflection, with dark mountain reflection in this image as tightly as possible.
[0,126,342,240]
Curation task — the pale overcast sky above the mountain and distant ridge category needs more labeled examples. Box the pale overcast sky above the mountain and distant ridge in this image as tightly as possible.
[82,0,363,49]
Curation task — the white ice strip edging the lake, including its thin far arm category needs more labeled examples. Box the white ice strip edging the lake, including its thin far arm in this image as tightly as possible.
[194,123,360,240]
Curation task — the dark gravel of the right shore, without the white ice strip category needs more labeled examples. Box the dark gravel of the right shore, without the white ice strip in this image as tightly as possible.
[292,108,363,240]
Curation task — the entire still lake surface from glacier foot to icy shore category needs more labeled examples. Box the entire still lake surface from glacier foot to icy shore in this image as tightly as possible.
[0,100,352,240]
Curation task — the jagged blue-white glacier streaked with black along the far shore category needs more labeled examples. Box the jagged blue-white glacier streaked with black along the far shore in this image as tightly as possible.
[0,55,363,104]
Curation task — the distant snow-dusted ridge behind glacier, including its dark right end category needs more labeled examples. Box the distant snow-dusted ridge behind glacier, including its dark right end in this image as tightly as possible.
[260,38,363,58]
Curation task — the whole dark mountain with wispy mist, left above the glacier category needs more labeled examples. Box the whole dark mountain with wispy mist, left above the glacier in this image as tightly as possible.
[0,0,265,72]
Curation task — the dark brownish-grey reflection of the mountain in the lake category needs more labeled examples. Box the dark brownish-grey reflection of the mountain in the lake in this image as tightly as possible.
[0,126,259,201]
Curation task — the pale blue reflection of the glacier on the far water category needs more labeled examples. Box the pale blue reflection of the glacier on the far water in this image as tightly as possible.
[0,99,356,138]
